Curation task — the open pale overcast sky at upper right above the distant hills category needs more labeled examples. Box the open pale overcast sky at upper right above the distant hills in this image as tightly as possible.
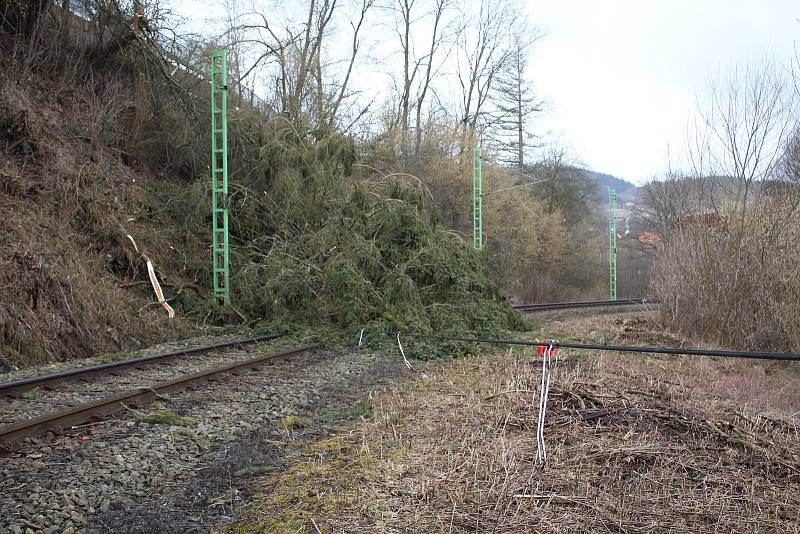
[528,0,800,183]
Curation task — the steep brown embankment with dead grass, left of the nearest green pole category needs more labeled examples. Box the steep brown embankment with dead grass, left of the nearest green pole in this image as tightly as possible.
[0,44,210,371]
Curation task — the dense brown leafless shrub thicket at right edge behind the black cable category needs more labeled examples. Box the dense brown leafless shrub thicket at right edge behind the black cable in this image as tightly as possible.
[653,201,800,351]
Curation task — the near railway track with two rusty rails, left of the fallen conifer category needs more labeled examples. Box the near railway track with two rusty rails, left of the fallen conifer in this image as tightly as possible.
[0,336,321,452]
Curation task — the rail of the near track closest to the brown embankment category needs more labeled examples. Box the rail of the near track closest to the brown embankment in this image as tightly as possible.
[0,334,283,395]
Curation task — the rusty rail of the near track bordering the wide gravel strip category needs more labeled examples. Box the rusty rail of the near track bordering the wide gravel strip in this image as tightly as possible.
[0,344,322,452]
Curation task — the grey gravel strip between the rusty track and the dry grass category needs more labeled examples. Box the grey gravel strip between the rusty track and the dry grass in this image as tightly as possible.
[0,343,407,534]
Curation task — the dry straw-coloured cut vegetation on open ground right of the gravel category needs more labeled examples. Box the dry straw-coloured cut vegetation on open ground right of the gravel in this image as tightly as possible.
[233,318,800,533]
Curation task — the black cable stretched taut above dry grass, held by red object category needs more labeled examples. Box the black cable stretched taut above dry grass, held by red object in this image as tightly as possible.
[401,333,800,362]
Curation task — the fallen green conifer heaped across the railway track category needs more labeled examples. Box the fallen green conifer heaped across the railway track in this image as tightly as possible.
[223,124,524,356]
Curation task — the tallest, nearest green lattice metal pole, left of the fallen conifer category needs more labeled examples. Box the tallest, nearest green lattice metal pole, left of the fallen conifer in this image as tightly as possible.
[211,50,231,306]
